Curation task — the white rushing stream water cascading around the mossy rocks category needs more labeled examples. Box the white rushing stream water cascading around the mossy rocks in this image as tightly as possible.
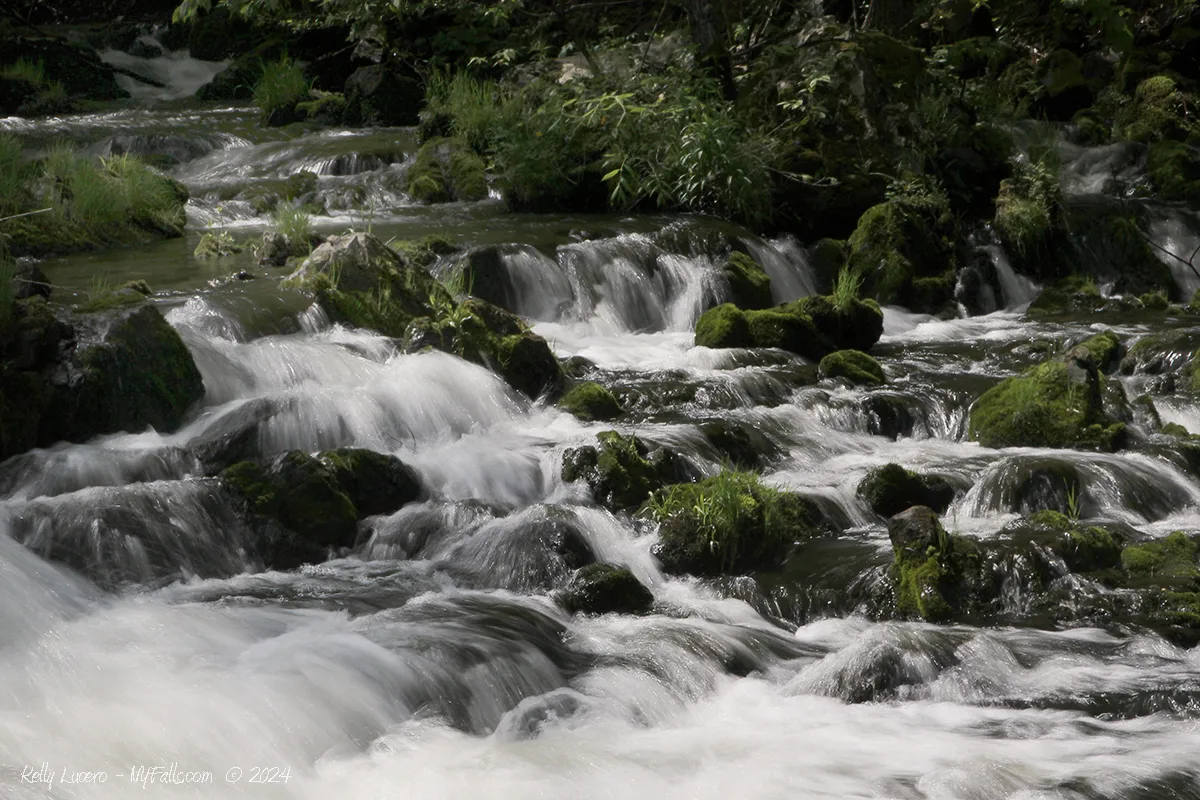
[0,45,1200,800]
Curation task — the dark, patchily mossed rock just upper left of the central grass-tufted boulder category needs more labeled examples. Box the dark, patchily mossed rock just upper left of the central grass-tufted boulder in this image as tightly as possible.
[562,431,691,511]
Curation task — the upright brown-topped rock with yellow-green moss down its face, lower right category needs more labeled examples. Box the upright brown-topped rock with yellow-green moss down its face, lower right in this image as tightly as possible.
[888,506,1000,622]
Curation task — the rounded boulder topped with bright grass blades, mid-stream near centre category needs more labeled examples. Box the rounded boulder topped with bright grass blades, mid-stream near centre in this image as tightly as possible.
[644,471,824,576]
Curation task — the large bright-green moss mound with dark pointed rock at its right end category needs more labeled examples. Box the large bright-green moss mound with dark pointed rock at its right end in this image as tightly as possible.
[968,355,1126,451]
